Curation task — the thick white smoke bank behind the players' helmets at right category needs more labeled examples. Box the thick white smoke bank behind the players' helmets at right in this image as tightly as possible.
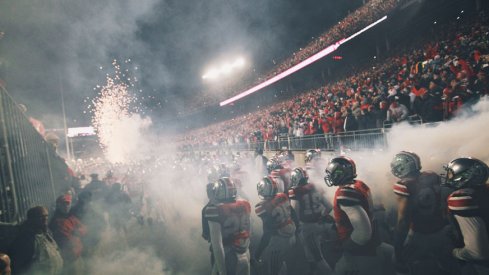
[336,97,489,206]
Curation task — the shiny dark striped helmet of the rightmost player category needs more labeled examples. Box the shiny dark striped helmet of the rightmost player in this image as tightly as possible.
[444,157,489,189]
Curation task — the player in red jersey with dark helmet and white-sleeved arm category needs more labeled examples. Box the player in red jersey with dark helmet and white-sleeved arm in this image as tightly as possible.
[324,156,394,275]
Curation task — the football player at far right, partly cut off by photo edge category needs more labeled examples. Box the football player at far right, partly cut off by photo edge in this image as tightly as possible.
[445,157,489,274]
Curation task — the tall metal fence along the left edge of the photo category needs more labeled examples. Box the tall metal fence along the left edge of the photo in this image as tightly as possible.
[0,87,70,223]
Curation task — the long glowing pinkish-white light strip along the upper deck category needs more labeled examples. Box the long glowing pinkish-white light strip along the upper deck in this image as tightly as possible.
[219,15,387,106]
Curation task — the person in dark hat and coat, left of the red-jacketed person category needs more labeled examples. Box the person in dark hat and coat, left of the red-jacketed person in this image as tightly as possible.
[9,206,63,275]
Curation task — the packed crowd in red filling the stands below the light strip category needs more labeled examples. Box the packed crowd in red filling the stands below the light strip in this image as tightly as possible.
[180,14,489,151]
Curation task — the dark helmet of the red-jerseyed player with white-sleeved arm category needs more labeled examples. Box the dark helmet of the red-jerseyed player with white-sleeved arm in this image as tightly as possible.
[324,156,357,187]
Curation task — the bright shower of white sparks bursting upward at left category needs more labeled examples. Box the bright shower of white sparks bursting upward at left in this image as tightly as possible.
[88,60,151,163]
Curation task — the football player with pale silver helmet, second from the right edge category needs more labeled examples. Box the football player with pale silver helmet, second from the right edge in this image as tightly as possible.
[391,151,451,275]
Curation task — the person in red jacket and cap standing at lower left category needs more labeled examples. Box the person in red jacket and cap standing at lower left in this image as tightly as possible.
[49,194,87,274]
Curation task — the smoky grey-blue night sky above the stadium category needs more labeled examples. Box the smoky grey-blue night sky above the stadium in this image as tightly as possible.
[0,0,361,128]
